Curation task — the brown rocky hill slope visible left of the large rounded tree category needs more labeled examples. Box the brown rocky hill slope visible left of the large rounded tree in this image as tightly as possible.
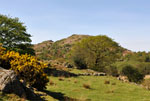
[34,34,89,60]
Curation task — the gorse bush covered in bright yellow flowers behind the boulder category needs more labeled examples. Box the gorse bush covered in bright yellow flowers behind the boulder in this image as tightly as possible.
[0,46,49,90]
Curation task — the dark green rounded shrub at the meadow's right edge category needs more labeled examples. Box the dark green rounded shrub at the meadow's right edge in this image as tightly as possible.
[122,65,144,83]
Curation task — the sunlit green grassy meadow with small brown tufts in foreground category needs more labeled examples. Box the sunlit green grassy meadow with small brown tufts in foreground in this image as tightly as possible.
[43,69,150,101]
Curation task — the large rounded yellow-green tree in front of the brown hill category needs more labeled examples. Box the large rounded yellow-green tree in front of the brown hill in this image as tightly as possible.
[70,35,120,72]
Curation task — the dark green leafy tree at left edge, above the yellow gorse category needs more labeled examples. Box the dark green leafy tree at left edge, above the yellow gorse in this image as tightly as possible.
[0,15,34,54]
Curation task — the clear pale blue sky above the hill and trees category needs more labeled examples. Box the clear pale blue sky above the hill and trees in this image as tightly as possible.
[0,0,150,51]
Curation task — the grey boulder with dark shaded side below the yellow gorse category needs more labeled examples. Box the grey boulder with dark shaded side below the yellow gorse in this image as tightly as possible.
[0,67,26,96]
